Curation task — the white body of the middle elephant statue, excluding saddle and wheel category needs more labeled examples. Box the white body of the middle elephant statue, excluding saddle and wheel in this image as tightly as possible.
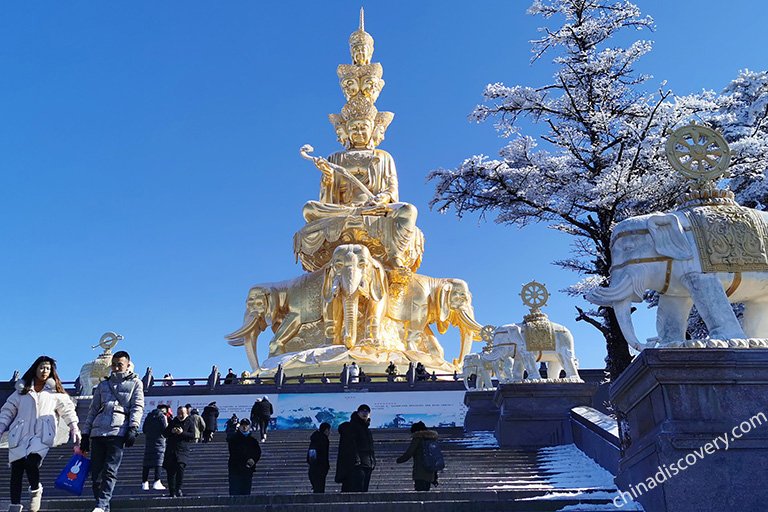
[491,322,582,382]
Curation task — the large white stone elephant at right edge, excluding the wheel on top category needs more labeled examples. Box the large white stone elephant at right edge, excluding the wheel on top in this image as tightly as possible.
[586,210,768,351]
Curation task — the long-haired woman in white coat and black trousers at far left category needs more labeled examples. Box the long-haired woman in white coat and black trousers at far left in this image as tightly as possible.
[0,356,80,512]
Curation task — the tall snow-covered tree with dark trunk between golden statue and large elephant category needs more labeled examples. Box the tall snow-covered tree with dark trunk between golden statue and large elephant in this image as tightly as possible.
[430,0,700,378]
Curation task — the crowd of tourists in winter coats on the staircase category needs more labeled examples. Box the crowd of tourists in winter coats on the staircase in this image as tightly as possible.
[0,351,442,512]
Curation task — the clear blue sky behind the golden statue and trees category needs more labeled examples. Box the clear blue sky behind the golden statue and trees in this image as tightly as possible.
[0,0,768,379]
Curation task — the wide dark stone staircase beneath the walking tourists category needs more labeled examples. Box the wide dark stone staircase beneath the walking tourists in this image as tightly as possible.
[0,428,615,512]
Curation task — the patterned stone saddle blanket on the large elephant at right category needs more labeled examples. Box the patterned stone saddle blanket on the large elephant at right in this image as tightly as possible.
[685,205,768,272]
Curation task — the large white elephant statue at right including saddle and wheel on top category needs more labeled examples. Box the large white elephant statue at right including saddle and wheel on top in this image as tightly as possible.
[587,124,768,350]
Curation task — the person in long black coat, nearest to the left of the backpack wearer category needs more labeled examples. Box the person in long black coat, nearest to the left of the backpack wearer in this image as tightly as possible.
[335,404,376,492]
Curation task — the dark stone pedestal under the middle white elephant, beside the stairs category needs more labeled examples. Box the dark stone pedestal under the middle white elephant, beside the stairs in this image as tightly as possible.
[493,382,597,449]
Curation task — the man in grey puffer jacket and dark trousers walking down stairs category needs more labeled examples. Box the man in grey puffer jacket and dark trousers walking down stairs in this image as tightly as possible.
[80,350,144,512]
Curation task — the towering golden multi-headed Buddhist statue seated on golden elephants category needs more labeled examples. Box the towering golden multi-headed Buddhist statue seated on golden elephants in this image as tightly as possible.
[227,9,481,375]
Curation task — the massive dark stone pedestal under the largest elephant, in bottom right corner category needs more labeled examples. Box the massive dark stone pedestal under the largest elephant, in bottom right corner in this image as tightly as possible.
[610,349,768,512]
